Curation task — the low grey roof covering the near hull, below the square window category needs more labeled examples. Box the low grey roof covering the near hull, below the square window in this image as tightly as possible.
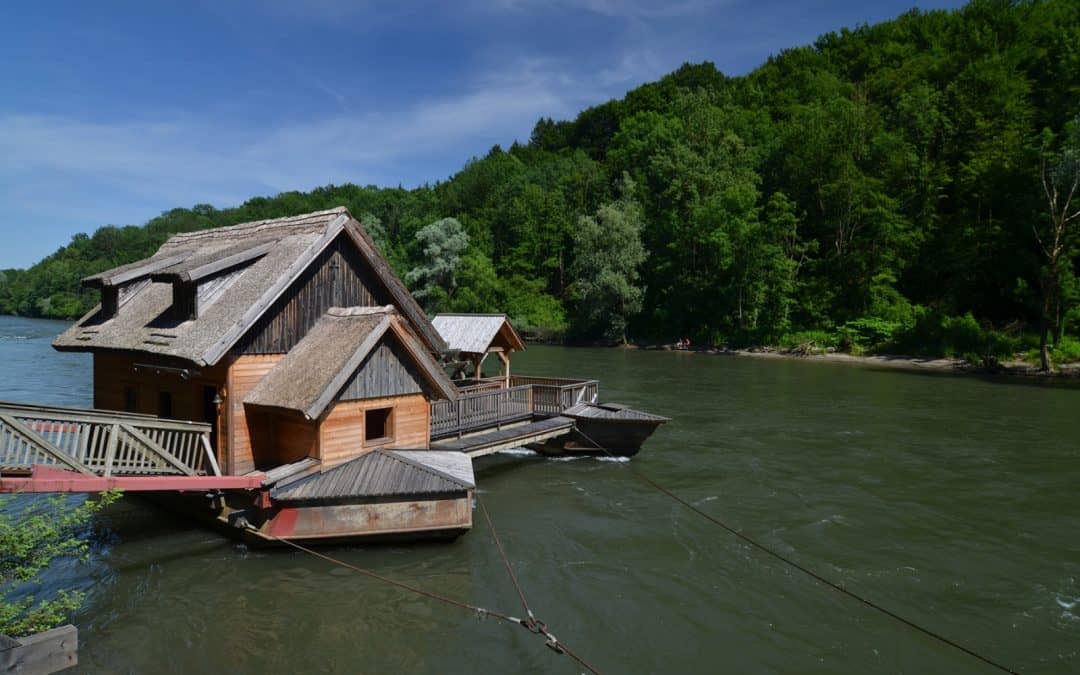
[270,449,475,503]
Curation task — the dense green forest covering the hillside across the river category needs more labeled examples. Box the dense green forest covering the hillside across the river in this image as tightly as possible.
[0,0,1080,361]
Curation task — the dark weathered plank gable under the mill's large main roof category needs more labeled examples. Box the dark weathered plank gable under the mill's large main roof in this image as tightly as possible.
[233,234,387,354]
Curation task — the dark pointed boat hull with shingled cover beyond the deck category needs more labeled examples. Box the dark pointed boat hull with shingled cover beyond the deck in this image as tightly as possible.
[540,403,671,457]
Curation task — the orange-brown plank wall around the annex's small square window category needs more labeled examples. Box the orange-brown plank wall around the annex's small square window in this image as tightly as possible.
[319,394,431,468]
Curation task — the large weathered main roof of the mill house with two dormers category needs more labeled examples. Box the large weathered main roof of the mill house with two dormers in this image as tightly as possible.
[53,207,446,365]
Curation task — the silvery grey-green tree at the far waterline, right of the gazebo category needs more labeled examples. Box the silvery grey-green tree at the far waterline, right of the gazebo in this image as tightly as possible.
[571,174,646,343]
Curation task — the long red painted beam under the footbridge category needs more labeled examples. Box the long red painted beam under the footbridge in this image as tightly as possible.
[0,464,266,492]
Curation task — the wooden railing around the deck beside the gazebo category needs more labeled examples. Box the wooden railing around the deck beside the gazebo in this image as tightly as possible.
[431,376,599,438]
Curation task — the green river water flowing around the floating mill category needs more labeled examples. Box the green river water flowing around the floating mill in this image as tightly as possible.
[0,318,1080,674]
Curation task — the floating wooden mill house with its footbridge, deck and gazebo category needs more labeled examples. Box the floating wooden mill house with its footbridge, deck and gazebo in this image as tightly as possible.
[0,207,662,540]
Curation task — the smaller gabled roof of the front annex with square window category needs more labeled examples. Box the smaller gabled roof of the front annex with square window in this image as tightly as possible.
[244,306,457,419]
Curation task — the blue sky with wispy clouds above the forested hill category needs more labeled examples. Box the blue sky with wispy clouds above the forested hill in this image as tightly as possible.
[0,0,961,269]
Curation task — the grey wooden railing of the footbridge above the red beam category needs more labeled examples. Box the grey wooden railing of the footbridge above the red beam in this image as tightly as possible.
[0,402,221,476]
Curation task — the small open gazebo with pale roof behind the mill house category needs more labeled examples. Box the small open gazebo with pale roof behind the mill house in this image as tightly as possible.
[431,314,525,387]
